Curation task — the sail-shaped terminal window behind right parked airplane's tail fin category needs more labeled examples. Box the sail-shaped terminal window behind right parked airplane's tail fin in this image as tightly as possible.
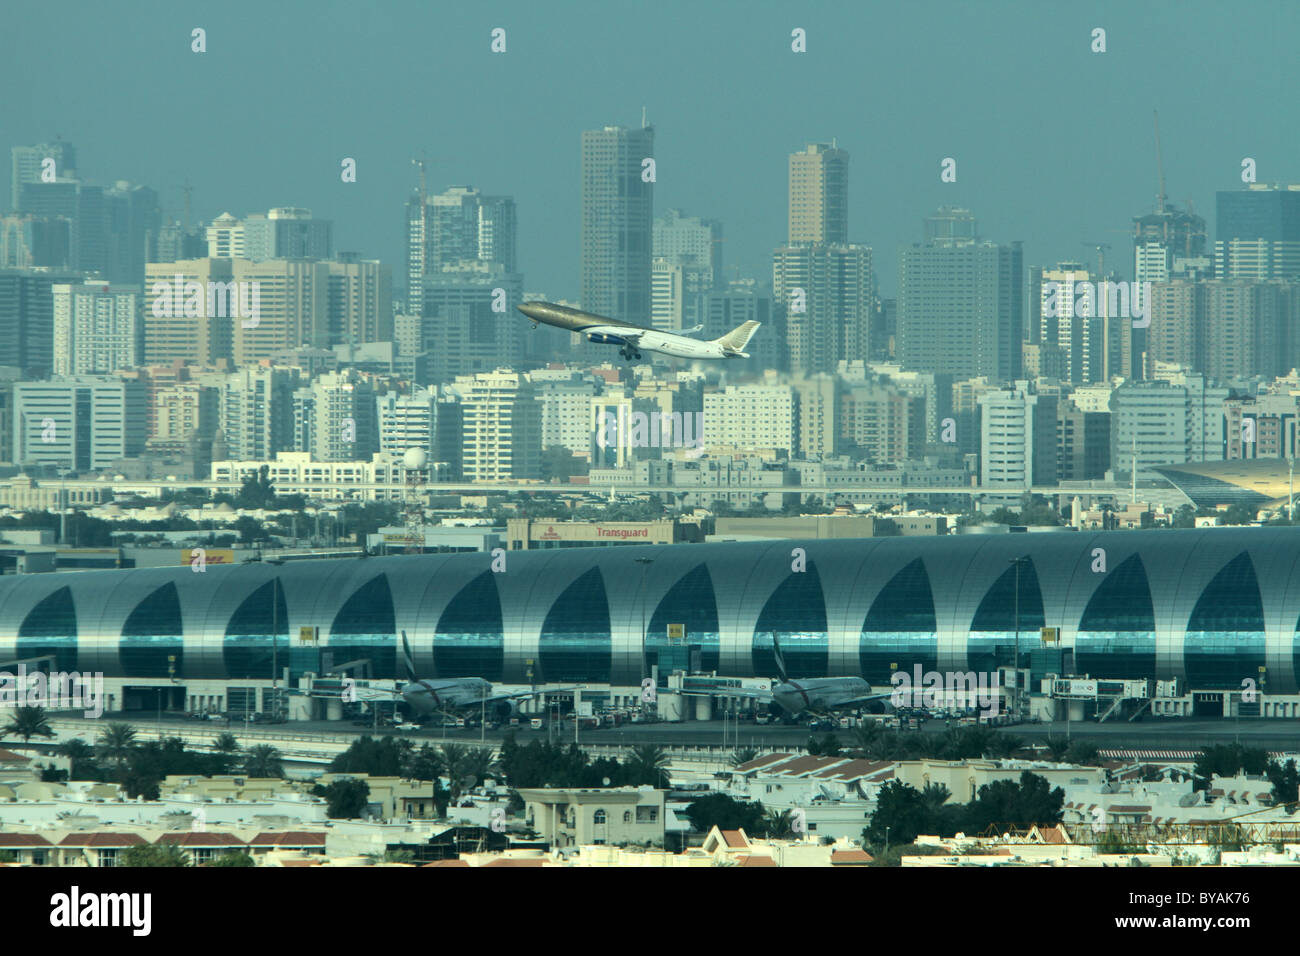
[751,561,831,680]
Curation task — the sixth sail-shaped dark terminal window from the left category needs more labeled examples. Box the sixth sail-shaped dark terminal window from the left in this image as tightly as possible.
[537,567,612,682]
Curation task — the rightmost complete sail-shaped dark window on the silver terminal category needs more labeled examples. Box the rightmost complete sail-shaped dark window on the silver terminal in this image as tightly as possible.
[1183,553,1265,689]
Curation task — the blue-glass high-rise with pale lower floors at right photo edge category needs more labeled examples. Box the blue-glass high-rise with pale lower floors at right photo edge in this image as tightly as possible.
[1214,183,1300,280]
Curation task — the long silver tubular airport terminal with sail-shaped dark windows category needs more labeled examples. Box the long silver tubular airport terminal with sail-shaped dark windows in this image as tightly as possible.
[0,528,1300,713]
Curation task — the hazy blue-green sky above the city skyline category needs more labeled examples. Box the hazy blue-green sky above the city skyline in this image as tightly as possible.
[0,0,1300,298]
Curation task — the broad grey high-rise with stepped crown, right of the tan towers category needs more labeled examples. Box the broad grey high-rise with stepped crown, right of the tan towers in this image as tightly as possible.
[897,208,1024,382]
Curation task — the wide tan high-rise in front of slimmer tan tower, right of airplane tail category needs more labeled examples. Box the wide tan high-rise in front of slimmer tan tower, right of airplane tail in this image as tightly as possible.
[772,242,876,375]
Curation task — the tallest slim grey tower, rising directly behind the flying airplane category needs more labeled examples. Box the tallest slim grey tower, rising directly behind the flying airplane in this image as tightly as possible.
[581,126,654,335]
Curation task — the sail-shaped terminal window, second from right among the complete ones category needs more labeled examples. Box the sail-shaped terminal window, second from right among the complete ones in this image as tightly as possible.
[1074,554,1156,680]
